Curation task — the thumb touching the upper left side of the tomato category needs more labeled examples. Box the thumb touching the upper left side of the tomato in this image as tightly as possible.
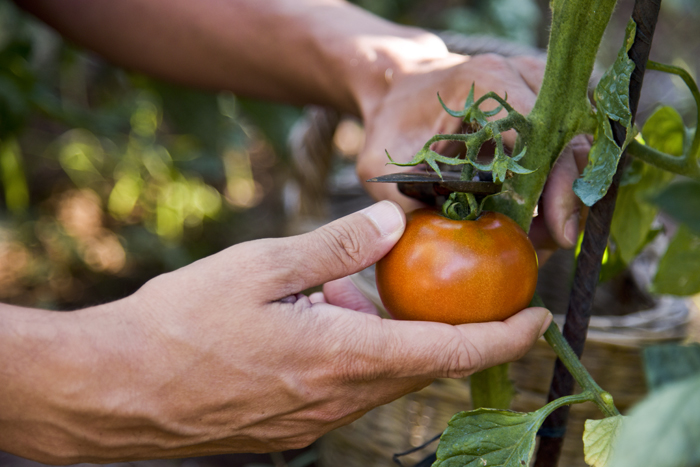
[253,201,406,300]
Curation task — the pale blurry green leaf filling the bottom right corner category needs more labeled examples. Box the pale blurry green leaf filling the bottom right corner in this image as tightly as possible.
[611,376,700,467]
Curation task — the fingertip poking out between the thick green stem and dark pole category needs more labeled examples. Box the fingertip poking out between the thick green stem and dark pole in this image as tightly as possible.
[541,138,586,248]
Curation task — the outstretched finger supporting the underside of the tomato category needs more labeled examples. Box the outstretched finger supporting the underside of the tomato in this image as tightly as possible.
[372,308,552,378]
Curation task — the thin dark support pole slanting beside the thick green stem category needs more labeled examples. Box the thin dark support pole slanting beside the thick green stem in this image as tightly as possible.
[535,0,661,467]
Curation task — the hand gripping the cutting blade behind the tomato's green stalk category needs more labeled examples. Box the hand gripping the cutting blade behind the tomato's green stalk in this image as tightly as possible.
[357,54,590,264]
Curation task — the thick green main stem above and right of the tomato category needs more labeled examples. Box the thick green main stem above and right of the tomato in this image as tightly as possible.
[489,0,616,231]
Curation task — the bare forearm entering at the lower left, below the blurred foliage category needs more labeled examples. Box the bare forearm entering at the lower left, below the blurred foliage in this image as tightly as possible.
[0,304,152,464]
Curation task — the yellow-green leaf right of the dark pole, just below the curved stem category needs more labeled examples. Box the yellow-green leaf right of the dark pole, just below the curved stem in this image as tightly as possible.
[610,163,673,263]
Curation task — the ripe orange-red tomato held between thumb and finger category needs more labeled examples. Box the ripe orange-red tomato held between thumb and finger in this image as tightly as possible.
[376,209,538,324]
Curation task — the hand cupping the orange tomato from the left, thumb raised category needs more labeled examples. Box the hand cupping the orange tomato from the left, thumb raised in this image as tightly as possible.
[9,201,551,463]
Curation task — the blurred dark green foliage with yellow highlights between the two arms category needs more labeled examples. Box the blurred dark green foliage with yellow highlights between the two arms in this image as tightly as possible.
[0,1,300,309]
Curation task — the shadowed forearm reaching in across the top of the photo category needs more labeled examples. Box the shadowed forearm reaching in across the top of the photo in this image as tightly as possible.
[16,0,447,115]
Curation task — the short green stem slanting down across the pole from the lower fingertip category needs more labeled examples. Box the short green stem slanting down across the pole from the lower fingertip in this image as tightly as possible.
[544,323,620,417]
